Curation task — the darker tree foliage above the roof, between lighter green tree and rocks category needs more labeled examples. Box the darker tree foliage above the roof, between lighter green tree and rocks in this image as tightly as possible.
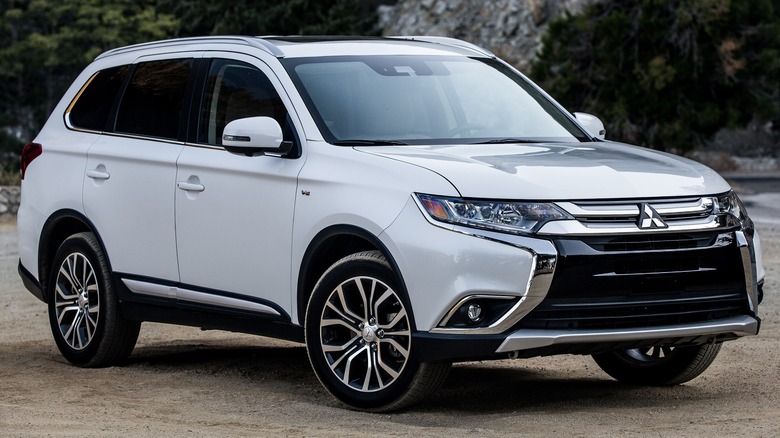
[159,0,380,36]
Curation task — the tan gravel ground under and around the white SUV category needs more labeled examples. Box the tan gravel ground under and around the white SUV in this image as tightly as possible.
[0,181,780,438]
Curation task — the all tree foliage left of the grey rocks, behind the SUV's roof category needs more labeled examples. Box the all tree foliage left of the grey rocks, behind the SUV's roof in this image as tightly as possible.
[0,0,379,178]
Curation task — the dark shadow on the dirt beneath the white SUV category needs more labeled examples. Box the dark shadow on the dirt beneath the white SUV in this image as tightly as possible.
[126,343,710,421]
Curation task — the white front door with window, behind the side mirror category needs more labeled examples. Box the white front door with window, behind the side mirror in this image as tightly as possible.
[175,54,304,319]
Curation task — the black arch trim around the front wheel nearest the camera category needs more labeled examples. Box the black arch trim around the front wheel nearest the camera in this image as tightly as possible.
[296,225,416,331]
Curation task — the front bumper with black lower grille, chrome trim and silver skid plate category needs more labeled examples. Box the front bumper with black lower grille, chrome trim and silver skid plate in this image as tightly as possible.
[400,193,762,362]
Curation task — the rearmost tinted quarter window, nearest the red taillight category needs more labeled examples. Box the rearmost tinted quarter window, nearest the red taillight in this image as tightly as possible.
[68,65,130,131]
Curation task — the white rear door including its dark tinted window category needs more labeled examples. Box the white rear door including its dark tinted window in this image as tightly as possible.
[83,53,200,281]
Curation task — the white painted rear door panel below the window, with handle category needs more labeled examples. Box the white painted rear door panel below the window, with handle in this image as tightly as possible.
[83,136,184,281]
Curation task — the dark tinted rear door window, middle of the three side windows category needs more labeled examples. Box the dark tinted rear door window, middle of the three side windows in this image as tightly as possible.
[116,59,192,139]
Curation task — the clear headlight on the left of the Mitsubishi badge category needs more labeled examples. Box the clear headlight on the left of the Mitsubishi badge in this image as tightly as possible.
[416,193,573,234]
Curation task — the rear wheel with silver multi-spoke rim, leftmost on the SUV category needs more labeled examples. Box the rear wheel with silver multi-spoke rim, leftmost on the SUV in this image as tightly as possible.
[47,233,141,367]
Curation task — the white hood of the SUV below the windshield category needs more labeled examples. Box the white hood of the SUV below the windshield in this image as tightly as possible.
[355,142,730,200]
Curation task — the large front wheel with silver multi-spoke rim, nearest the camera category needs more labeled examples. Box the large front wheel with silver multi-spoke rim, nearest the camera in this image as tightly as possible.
[306,251,450,412]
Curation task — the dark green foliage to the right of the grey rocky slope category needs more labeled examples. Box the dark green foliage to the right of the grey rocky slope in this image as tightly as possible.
[532,0,780,152]
